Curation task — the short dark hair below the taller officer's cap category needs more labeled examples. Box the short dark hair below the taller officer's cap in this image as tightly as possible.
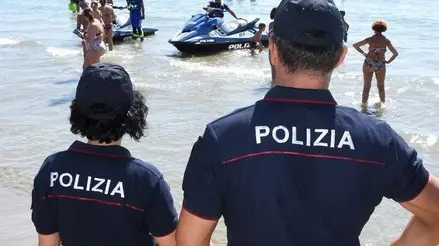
[271,33,343,74]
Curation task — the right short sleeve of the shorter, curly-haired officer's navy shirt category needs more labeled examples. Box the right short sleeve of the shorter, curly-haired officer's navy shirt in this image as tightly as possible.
[146,178,178,237]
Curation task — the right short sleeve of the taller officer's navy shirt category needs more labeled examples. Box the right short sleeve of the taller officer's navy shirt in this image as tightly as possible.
[385,126,429,202]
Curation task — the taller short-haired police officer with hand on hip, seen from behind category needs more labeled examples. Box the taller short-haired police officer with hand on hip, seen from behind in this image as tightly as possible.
[177,0,439,246]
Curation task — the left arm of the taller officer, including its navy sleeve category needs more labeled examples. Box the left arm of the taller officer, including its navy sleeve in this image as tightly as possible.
[177,127,224,246]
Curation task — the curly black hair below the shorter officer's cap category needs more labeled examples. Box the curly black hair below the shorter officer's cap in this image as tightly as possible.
[69,90,148,143]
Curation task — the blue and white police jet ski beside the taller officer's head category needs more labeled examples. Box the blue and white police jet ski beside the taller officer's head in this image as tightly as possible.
[168,8,268,53]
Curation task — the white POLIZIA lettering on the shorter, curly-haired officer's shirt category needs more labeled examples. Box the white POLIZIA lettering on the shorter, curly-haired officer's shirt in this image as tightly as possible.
[50,172,125,198]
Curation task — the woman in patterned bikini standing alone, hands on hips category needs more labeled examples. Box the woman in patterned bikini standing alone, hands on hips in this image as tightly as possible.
[353,20,398,107]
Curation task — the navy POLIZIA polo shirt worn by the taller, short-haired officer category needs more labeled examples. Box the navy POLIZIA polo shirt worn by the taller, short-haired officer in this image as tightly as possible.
[183,86,429,246]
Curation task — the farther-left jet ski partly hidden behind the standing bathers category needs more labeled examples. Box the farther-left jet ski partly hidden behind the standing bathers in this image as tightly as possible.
[113,10,158,42]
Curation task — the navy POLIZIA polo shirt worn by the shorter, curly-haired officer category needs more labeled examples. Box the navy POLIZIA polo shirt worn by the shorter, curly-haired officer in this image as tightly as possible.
[32,141,178,246]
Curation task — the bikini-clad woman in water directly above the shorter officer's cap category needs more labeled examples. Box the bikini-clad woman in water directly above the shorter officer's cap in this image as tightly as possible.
[82,8,106,69]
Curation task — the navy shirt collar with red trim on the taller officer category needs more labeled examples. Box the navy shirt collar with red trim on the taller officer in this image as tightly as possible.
[261,86,337,106]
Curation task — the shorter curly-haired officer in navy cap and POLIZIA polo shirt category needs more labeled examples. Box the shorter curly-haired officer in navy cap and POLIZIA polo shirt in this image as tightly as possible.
[32,63,178,246]
